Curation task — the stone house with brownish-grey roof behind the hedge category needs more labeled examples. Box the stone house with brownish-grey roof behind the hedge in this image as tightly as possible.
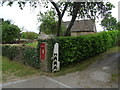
[63,20,97,36]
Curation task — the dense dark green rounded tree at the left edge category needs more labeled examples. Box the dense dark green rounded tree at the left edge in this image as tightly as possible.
[2,19,21,43]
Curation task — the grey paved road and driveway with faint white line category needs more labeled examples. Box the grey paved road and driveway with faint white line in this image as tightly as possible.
[0,52,120,88]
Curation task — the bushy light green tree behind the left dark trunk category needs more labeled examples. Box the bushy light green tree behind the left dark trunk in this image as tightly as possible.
[38,10,66,35]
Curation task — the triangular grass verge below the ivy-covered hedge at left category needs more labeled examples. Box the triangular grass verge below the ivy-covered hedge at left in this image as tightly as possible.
[2,57,41,83]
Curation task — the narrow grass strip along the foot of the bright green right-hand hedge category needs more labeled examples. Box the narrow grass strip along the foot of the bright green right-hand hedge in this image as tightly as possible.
[45,46,120,76]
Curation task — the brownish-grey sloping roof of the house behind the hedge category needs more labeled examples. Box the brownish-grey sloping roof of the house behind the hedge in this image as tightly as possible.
[63,20,96,32]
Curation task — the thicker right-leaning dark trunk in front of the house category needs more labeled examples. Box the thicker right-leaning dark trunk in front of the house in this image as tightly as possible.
[63,2,80,36]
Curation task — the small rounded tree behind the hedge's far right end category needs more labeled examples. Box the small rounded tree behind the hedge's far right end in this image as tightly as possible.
[101,15,117,31]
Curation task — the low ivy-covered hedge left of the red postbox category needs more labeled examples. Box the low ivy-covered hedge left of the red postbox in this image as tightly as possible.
[2,45,39,68]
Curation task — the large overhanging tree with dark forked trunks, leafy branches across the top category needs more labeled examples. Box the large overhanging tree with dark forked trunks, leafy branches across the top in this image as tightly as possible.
[3,0,114,36]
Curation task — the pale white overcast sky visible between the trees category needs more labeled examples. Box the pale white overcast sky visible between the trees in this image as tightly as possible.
[0,0,120,33]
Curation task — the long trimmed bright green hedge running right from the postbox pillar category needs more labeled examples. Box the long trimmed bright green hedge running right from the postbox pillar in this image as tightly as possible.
[39,31,120,66]
